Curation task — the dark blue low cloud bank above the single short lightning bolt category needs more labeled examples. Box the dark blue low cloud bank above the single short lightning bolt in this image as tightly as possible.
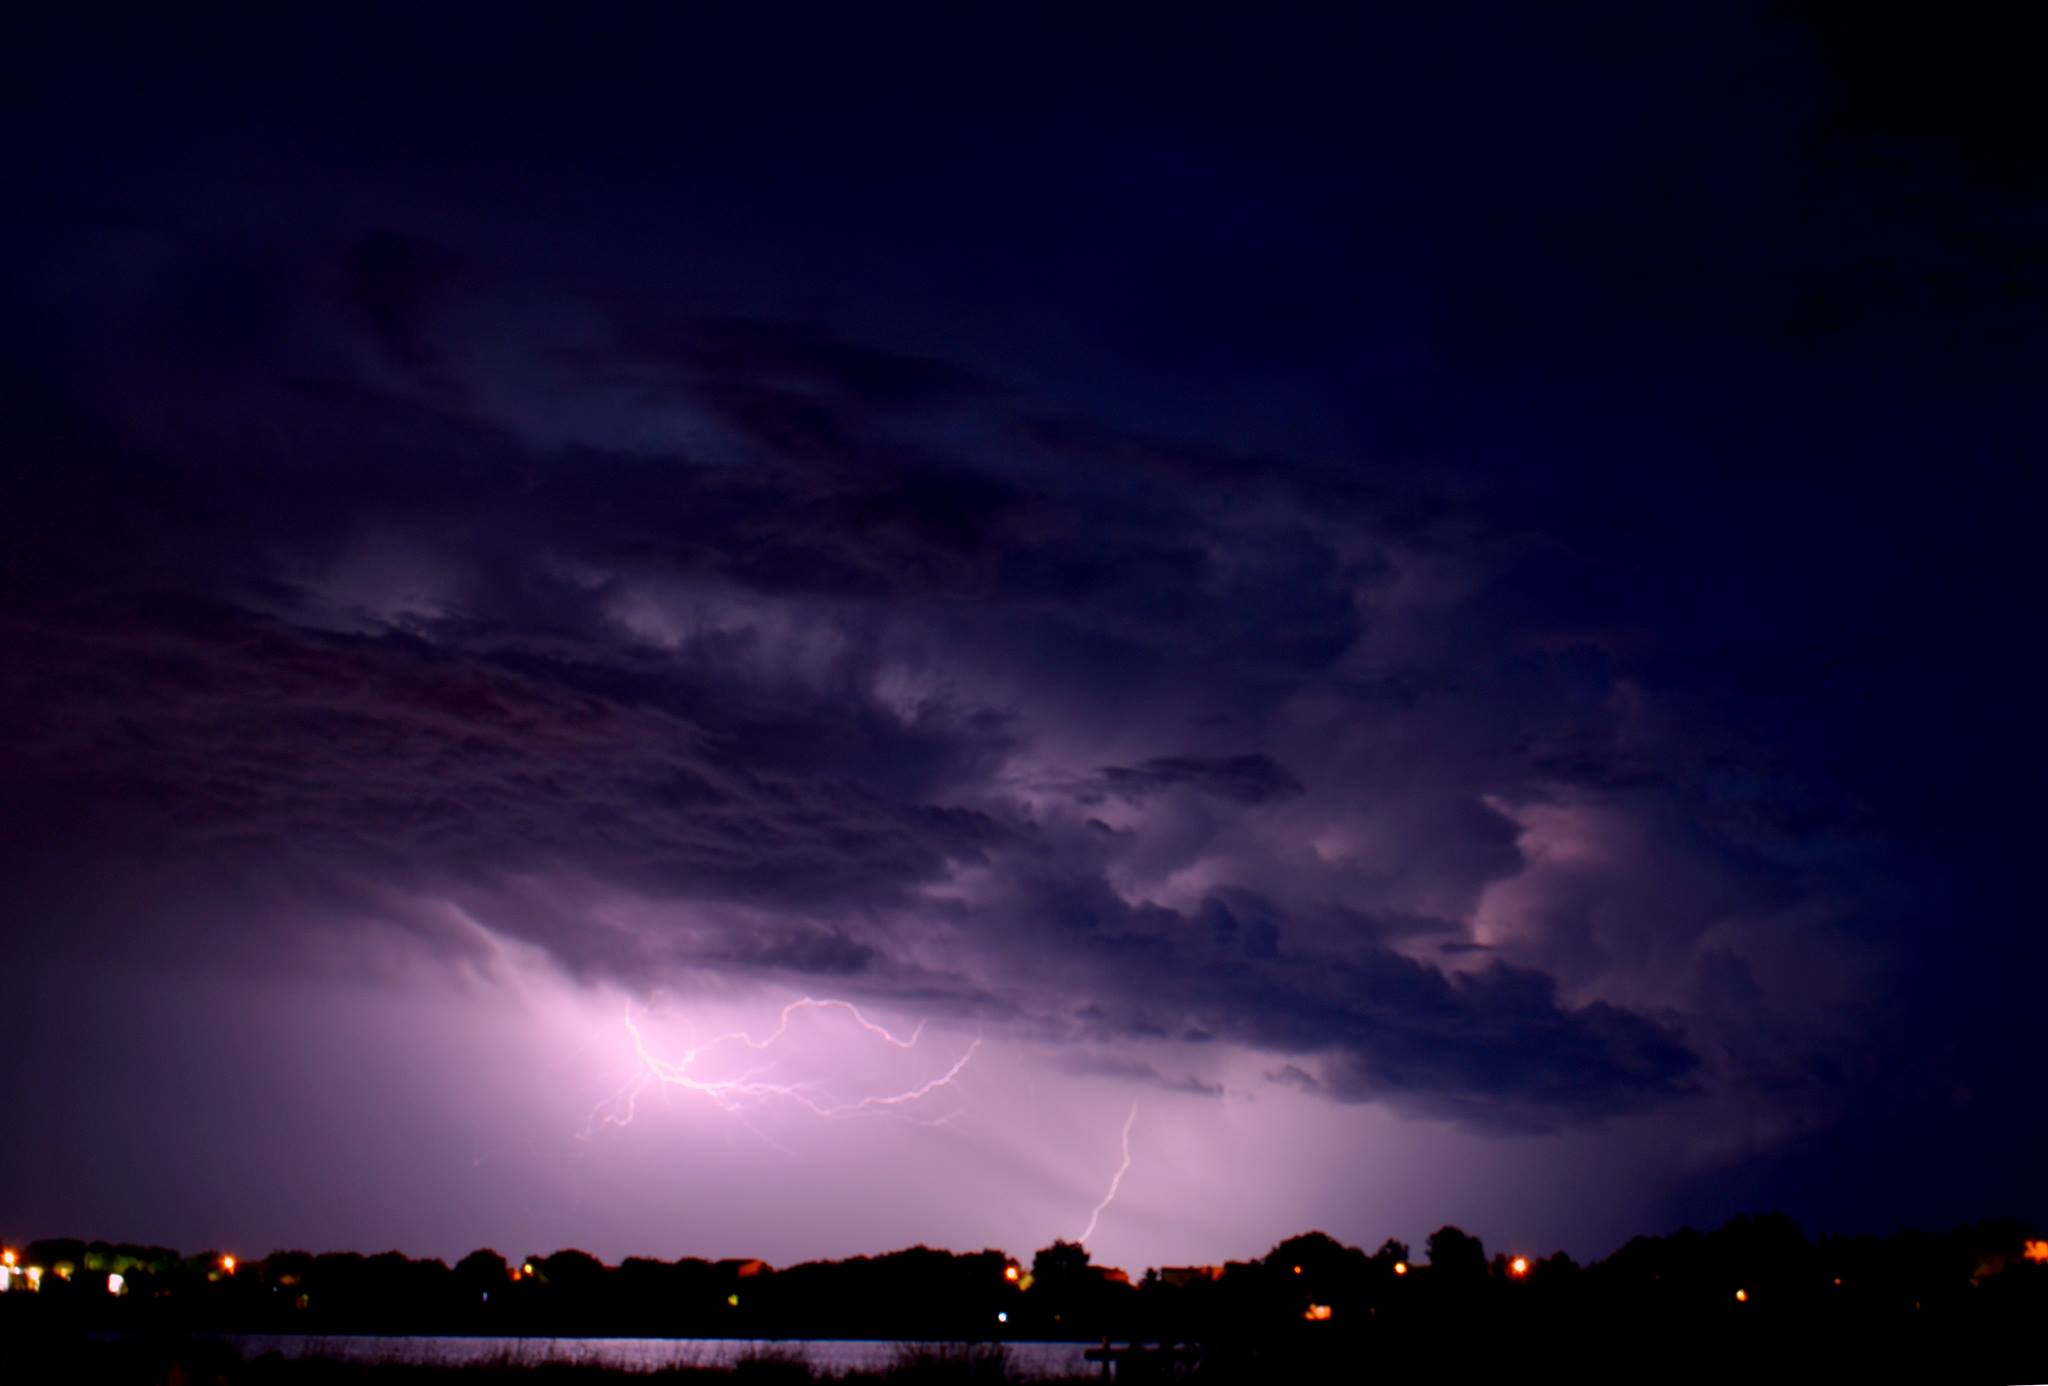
[974,880,1700,1130]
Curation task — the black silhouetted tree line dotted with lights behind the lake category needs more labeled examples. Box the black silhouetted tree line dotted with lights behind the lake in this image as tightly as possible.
[0,1216,2048,1380]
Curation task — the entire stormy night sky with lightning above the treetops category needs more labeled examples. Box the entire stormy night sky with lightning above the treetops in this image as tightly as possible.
[0,4,2048,1267]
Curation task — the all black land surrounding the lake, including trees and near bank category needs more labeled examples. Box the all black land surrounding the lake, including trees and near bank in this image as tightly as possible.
[0,1216,2048,1386]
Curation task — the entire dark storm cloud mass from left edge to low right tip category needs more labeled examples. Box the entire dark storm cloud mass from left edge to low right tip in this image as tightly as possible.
[6,253,1694,1126]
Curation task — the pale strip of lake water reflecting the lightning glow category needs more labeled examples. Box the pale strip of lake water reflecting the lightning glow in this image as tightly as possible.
[225,1333,1094,1376]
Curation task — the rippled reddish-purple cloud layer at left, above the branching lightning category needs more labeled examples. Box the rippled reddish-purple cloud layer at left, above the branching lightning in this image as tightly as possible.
[6,573,997,929]
